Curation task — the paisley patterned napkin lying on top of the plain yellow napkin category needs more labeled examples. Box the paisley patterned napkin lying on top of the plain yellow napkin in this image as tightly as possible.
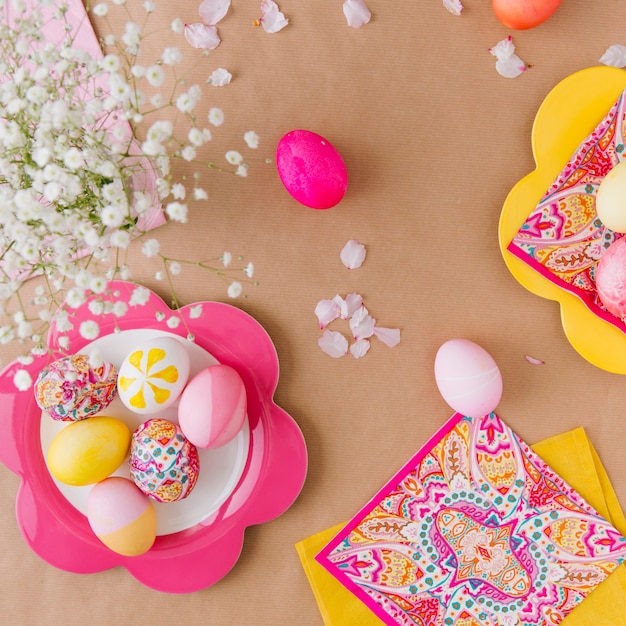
[316,413,626,626]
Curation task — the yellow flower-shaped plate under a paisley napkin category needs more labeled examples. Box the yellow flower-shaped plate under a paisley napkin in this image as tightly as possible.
[498,67,626,374]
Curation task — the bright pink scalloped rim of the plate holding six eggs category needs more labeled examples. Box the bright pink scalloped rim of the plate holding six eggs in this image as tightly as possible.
[0,281,307,593]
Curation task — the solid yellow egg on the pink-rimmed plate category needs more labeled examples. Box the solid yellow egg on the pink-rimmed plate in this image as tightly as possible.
[47,415,130,487]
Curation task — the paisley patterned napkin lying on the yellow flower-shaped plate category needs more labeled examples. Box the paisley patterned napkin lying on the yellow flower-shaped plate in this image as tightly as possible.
[507,92,626,332]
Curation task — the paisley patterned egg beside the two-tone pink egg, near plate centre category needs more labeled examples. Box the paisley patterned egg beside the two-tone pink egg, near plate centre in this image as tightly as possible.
[129,418,200,502]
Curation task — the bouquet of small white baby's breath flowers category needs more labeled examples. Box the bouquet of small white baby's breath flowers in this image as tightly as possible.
[0,0,258,360]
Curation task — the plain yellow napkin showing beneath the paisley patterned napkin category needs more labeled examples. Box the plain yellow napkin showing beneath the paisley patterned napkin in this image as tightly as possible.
[296,428,626,626]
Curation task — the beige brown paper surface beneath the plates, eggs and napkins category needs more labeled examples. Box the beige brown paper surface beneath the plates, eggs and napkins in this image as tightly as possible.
[0,0,626,626]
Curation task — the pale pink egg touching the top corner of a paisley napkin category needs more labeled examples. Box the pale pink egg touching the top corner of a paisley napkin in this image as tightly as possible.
[435,339,502,417]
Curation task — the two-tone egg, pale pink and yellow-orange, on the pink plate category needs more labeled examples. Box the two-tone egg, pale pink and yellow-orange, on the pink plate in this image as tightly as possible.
[87,476,157,556]
